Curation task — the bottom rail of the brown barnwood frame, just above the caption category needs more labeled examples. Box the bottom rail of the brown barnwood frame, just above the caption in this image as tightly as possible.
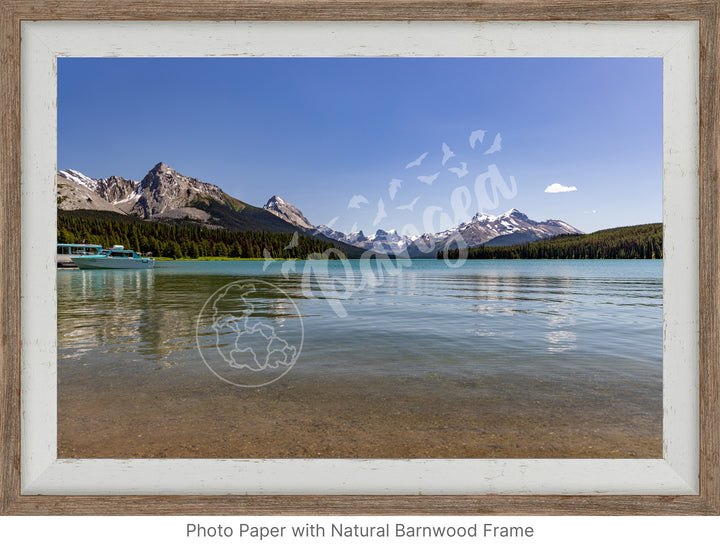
[4,495,716,515]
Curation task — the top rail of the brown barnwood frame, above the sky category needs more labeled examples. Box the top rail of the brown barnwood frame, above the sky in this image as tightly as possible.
[4,0,717,21]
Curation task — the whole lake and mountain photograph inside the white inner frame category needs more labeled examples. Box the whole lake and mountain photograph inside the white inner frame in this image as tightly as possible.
[56,57,663,459]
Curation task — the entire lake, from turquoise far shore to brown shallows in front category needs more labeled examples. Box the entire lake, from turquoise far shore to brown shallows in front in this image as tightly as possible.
[57,260,663,458]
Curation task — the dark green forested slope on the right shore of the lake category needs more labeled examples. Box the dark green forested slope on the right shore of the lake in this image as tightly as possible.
[438,223,663,259]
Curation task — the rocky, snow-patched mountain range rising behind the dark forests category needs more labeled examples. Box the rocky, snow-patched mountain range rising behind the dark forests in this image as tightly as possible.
[57,163,582,258]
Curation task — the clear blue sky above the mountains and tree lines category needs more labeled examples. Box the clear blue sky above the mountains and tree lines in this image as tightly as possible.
[58,58,662,234]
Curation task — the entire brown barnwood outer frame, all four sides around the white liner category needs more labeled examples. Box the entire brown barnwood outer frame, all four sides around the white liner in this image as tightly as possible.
[0,0,720,515]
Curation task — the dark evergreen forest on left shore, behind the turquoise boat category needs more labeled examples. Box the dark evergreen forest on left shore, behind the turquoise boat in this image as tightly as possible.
[57,211,348,259]
